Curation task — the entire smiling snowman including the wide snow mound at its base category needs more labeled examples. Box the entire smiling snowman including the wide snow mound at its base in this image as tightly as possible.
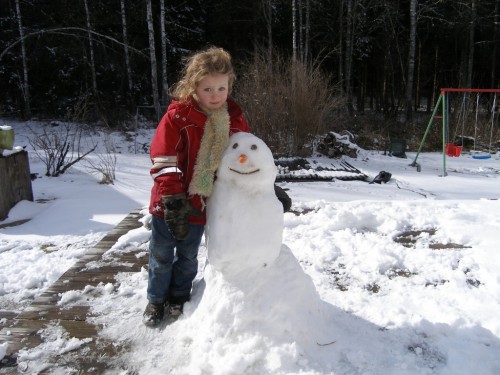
[188,133,333,373]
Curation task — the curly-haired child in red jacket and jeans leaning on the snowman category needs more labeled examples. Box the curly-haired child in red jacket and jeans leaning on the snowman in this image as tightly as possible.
[143,47,249,327]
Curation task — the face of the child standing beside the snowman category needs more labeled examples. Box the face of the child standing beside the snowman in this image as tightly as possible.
[195,73,229,110]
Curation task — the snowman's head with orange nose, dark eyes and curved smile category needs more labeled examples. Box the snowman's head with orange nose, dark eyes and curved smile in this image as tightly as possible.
[217,132,278,189]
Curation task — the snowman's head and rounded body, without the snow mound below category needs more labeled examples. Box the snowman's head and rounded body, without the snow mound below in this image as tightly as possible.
[206,133,283,279]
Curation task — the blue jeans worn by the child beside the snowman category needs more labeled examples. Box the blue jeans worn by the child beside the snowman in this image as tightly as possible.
[147,215,205,304]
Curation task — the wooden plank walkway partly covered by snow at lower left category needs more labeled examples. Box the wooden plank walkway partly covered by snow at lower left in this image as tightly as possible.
[0,209,148,374]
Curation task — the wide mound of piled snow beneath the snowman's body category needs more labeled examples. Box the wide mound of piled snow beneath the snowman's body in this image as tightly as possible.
[185,245,334,355]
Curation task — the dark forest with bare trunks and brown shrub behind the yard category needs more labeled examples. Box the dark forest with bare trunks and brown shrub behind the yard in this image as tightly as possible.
[0,0,500,155]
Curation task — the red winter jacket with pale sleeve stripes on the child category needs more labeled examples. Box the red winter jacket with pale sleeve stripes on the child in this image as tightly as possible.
[149,98,249,224]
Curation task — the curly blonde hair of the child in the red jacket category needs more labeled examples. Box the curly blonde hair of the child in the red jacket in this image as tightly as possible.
[172,47,236,102]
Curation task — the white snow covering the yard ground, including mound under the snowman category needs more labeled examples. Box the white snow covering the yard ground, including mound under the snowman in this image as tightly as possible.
[0,121,500,375]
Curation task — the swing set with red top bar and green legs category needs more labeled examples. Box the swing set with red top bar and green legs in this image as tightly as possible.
[410,88,500,176]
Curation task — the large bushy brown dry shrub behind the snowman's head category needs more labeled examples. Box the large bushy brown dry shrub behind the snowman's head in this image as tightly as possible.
[235,49,343,156]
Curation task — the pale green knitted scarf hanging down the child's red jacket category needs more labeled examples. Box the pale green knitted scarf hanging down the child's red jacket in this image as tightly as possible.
[188,104,229,197]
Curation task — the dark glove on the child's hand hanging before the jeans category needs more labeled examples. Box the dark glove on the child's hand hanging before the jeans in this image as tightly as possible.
[161,193,200,240]
